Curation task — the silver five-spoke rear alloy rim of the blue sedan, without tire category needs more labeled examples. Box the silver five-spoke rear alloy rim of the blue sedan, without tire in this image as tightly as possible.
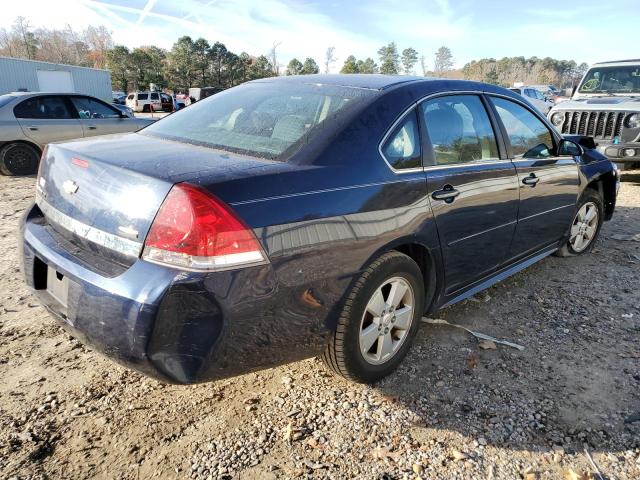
[359,277,415,365]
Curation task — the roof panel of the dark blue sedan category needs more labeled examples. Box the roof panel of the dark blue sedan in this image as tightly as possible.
[249,73,441,90]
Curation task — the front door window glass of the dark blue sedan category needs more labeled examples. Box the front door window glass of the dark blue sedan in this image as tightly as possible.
[492,97,554,158]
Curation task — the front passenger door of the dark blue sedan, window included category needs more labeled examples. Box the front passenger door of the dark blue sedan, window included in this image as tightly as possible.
[490,97,579,257]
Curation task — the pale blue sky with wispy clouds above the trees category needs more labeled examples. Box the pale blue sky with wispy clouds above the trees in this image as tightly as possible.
[0,0,640,72]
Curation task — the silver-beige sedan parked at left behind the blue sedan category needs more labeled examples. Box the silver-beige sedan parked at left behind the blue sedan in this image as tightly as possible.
[0,92,153,175]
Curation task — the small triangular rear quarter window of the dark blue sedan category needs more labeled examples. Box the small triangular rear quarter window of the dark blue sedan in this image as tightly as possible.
[382,111,422,170]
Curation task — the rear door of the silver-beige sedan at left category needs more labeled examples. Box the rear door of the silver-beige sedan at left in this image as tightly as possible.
[13,95,82,146]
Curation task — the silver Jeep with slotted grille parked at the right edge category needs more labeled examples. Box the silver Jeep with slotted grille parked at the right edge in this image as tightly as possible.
[549,60,640,169]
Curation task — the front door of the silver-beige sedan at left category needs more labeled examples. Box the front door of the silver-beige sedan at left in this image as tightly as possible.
[70,95,138,137]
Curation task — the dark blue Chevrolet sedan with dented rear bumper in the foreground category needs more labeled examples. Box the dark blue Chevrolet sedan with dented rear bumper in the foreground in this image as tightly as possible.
[21,75,619,383]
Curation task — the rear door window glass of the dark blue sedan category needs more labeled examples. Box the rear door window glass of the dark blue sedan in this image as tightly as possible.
[420,95,499,165]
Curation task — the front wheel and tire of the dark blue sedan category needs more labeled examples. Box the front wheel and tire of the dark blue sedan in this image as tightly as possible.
[556,188,604,257]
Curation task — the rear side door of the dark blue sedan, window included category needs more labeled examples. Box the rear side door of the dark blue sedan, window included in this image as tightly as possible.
[420,94,518,295]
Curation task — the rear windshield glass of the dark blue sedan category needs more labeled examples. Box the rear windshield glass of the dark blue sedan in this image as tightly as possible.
[141,82,374,159]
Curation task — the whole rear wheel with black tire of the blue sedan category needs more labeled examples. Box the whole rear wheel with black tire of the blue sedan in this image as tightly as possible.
[323,252,425,383]
